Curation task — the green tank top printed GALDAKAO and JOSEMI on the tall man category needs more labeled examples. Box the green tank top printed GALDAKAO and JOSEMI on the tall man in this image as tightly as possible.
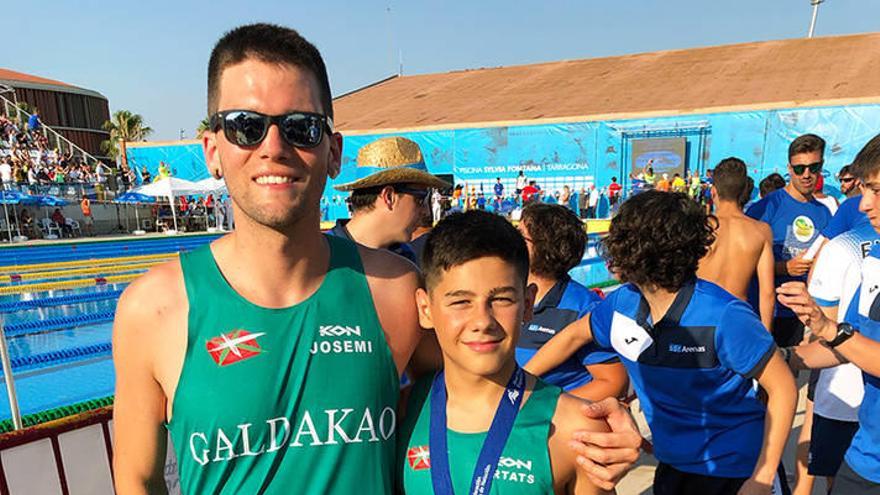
[167,236,399,495]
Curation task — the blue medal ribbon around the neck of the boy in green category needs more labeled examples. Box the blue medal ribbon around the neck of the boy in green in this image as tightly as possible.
[428,366,526,495]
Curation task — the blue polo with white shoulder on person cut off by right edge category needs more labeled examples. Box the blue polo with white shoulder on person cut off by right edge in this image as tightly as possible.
[845,246,880,483]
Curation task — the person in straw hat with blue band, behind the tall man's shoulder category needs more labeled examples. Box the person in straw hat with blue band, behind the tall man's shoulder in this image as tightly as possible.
[330,137,450,263]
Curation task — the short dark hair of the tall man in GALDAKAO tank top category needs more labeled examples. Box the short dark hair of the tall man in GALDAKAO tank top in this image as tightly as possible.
[208,23,333,118]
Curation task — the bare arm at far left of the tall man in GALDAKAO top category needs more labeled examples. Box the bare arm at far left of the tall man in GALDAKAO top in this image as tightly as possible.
[113,275,174,495]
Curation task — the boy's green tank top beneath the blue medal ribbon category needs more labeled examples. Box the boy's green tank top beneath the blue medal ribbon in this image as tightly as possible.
[397,376,562,495]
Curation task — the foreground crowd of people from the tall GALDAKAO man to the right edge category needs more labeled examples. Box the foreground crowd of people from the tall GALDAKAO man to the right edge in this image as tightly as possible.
[101,24,880,495]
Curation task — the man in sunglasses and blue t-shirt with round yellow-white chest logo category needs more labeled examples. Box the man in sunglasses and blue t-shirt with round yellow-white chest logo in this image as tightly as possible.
[746,134,831,347]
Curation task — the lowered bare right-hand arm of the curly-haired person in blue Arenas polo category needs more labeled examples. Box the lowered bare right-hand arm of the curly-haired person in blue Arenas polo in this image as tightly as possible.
[739,352,797,494]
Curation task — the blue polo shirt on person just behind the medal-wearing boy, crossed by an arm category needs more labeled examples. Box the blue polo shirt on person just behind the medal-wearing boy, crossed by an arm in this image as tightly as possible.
[516,275,619,390]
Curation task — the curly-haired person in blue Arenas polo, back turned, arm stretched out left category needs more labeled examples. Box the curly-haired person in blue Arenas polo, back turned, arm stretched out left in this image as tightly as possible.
[526,191,796,495]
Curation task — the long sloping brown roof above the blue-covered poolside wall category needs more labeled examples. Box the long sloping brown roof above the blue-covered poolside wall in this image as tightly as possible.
[334,33,880,134]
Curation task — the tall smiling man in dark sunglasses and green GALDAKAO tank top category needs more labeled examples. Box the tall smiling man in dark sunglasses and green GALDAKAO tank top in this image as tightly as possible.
[113,24,640,495]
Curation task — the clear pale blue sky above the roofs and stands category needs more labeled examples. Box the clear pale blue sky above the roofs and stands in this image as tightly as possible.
[0,0,880,140]
